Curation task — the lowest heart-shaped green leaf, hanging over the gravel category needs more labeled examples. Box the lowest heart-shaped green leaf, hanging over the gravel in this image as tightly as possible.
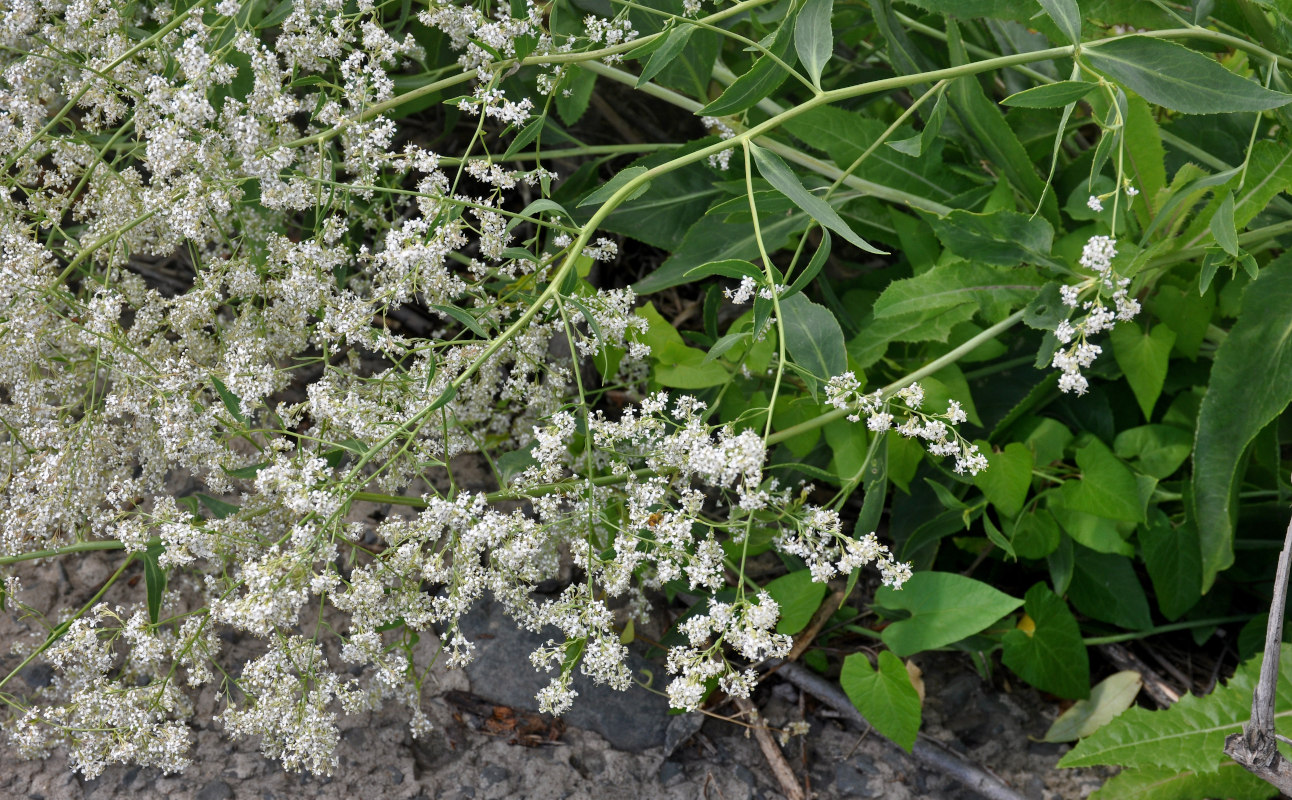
[839,650,921,752]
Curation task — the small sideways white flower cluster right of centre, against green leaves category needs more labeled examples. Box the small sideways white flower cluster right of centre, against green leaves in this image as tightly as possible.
[826,372,987,476]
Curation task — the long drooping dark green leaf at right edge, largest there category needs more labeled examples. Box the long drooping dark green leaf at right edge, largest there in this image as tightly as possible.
[1193,252,1292,592]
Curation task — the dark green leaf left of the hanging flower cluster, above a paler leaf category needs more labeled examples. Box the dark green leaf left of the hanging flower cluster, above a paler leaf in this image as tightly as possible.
[932,208,1057,266]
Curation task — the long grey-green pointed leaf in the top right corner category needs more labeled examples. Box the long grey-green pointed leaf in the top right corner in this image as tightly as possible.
[1081,36,1292,114]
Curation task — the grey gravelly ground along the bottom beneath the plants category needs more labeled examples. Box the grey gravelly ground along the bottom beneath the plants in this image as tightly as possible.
[0,553,1103,800]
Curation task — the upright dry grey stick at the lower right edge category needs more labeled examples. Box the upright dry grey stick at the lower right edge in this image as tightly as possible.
[1225,509,1292,794]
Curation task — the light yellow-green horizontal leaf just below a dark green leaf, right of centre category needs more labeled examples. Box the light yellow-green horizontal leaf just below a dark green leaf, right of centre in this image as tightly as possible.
[875,262,1040,319]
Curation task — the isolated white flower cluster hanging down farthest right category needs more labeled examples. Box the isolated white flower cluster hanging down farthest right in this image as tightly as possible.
[1050,235,1140,394]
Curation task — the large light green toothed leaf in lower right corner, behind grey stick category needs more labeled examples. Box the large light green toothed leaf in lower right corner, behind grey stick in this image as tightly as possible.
[1058,644,1292,773]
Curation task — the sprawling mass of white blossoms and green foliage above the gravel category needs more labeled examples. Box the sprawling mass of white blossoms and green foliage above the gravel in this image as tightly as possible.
[0,0,1292,796]
